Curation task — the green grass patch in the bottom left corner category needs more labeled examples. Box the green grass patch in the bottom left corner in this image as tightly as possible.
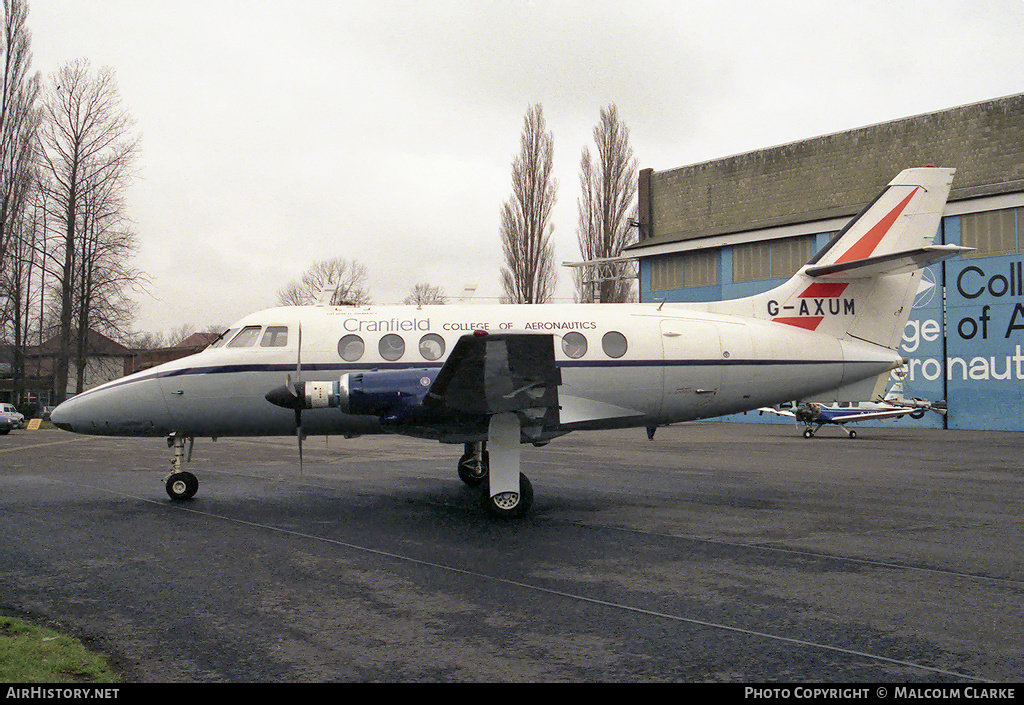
[0,615,121,683]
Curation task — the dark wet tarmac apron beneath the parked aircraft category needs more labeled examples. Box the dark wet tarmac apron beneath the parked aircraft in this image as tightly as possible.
[0,422,1024,682]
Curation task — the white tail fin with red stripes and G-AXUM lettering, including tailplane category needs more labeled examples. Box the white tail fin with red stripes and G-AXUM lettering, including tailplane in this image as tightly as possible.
[713,167,969,350]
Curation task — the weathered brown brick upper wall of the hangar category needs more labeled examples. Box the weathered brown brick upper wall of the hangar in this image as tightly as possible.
[640,94,1024,245]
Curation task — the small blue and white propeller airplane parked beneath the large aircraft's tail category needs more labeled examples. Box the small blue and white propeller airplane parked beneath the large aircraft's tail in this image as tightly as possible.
[758,381,946,439]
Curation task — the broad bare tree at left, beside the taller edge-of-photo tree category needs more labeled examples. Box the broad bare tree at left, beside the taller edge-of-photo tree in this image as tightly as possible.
[39,59,138,402]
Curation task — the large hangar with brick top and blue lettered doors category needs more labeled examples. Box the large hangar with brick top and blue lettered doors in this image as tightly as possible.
[624,94,1024,430]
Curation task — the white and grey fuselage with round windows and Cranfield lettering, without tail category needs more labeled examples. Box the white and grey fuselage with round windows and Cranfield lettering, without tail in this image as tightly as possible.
[54,304,900,443]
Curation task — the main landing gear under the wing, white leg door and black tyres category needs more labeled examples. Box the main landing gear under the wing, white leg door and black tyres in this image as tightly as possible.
[459,413,534,519]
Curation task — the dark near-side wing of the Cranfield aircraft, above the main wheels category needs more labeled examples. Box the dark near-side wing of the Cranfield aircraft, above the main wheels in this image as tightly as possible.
[424,333,562,420]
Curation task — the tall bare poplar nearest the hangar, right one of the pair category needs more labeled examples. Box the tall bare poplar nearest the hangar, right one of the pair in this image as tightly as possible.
[575,103,637,303]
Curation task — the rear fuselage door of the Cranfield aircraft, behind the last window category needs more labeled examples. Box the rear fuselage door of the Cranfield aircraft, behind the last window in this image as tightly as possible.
[662,319,722,419]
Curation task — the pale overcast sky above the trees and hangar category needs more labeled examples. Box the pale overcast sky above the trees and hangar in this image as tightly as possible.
[29,0,1024,331]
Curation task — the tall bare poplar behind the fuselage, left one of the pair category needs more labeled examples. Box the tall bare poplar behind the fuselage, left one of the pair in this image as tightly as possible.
[501,103,558,303]
